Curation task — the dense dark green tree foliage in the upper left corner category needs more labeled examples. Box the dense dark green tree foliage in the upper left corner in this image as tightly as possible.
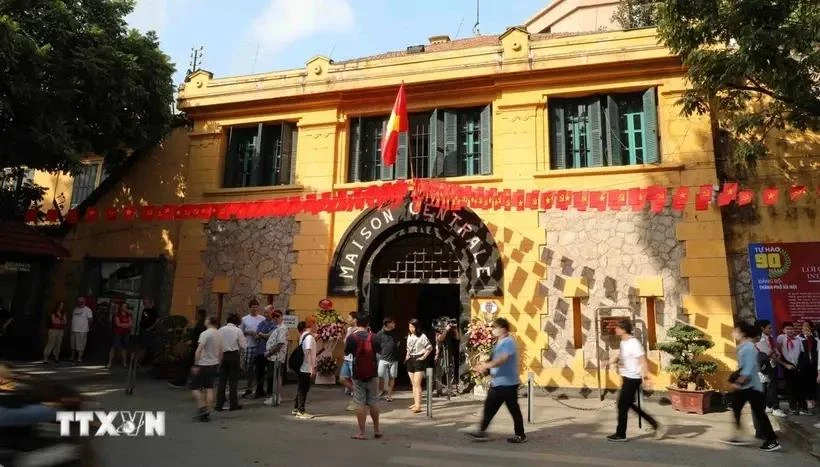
[0,0,174,219]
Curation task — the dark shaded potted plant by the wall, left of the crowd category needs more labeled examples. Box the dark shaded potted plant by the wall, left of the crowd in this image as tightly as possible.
[154,315,190,379]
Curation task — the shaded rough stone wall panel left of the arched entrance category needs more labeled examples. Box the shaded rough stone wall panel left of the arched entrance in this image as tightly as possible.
[200,217,297,316]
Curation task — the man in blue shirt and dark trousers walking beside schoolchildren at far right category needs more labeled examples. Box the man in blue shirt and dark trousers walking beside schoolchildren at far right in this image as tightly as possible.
[721,323,780,451]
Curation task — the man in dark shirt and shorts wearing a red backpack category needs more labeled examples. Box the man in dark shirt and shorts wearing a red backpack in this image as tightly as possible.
[345,313,382,440]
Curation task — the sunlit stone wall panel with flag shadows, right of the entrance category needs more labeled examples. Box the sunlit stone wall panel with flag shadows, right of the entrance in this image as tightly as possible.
[540,210,688,368]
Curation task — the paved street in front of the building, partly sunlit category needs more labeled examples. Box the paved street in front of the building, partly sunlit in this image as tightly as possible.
[9,364,817,467]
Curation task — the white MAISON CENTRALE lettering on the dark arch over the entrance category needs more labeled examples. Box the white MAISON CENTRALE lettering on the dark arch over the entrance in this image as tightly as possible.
[338,203,490,279]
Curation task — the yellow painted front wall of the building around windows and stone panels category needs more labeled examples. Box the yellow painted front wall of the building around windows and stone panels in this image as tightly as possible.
[178,29,734,387]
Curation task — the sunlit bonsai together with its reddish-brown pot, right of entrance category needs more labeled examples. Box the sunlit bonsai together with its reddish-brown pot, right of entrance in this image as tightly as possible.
[658,324,718,414]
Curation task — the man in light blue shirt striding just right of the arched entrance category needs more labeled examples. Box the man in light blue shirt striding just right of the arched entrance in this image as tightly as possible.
[470,318,527,444]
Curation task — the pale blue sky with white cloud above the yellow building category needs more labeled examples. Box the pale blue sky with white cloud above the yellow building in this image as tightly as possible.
[127,0,549,84]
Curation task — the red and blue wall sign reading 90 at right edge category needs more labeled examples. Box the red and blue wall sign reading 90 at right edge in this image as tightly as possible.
[749,242,820,327]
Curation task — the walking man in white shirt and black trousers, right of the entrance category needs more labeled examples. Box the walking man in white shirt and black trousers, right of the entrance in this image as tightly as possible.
[606,318,666,442]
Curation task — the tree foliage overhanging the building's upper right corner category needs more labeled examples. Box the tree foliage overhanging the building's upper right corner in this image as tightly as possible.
[658,0,820,170]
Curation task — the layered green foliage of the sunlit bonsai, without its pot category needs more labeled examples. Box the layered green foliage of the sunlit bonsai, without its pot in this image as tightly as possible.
[658,324,718,391]
